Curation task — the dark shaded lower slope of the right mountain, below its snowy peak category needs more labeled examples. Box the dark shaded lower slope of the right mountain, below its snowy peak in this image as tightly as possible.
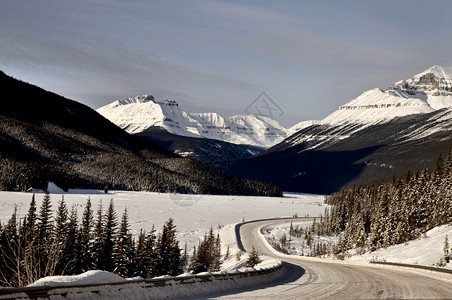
[229,108,452,194]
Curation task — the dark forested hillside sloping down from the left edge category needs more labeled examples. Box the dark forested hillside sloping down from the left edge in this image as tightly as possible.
[0,72,281,195]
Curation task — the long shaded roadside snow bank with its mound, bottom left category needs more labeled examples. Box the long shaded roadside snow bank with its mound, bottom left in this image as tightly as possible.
[0,268,286,300]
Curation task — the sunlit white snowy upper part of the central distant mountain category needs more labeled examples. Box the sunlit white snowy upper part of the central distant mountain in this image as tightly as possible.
[97,95,315,148]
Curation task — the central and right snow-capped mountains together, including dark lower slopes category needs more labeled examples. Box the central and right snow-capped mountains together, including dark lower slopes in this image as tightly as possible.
[98,66,452,193]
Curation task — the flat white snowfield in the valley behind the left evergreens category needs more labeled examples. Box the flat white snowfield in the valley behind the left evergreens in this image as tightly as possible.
[0,187,325,262]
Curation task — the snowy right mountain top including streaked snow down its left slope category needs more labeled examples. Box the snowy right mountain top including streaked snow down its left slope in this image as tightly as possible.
[284,65,452,149]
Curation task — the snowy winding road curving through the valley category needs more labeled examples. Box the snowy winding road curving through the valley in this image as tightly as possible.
[212,219,452,300]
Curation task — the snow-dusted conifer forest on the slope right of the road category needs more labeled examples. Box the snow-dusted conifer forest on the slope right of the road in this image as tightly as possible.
[310,150,452,258]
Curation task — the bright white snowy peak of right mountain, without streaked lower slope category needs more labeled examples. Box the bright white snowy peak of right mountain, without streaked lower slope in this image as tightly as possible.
[321,65,452,124]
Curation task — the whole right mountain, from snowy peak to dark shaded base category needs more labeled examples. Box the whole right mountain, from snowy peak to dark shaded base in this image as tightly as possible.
[229,66,452,193]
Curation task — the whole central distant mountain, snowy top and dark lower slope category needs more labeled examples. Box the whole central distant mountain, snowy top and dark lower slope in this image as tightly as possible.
[97,88,317,172]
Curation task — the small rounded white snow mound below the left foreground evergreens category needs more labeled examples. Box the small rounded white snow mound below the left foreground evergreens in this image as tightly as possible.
[28,270,126,287]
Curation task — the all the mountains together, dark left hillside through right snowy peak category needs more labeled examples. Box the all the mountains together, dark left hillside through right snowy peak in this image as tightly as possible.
[7,66,452,195]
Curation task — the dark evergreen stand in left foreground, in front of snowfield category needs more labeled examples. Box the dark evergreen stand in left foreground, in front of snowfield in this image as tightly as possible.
[0,194,187,287]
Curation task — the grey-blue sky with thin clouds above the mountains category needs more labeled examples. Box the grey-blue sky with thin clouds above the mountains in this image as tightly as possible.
[0,0,452,127]
